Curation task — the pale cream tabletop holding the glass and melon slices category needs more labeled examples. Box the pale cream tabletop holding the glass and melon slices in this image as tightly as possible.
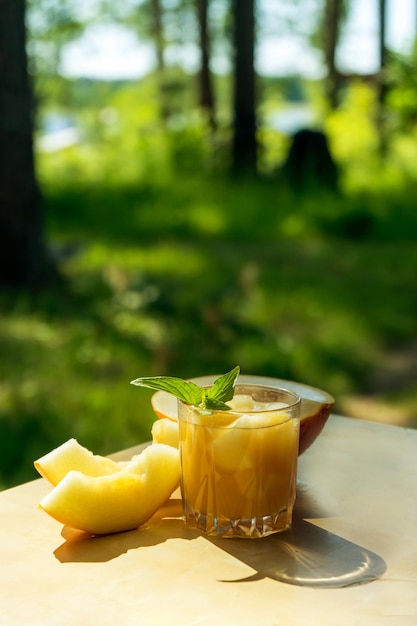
[0,415,417,626]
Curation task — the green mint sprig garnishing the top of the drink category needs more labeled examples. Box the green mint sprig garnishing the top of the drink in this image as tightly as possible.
[130,365,240,411]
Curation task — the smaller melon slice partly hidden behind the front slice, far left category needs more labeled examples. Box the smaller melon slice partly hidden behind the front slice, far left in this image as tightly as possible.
[34,439,124,485]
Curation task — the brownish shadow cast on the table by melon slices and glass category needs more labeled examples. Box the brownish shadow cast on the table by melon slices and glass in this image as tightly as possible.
[54,490,386,588]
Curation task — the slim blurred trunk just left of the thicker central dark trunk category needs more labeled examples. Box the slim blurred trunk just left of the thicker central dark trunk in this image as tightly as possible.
[196,0,216,128]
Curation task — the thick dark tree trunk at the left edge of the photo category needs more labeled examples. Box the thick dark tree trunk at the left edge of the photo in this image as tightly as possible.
[0,0,49,287]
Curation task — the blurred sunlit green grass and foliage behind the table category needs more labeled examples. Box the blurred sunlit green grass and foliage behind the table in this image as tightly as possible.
[0,72,417,487]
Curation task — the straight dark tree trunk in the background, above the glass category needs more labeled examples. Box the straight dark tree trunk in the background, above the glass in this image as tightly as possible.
[232,0,257,174]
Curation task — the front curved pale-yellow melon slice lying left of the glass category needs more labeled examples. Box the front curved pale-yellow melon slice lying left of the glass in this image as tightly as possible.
[39,444,180,535]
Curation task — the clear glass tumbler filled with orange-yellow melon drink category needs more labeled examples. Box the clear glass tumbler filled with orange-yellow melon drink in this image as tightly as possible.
[178,385,301,537]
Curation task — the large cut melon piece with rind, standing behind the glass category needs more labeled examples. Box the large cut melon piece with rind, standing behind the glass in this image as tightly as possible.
[151,374,334,455]
